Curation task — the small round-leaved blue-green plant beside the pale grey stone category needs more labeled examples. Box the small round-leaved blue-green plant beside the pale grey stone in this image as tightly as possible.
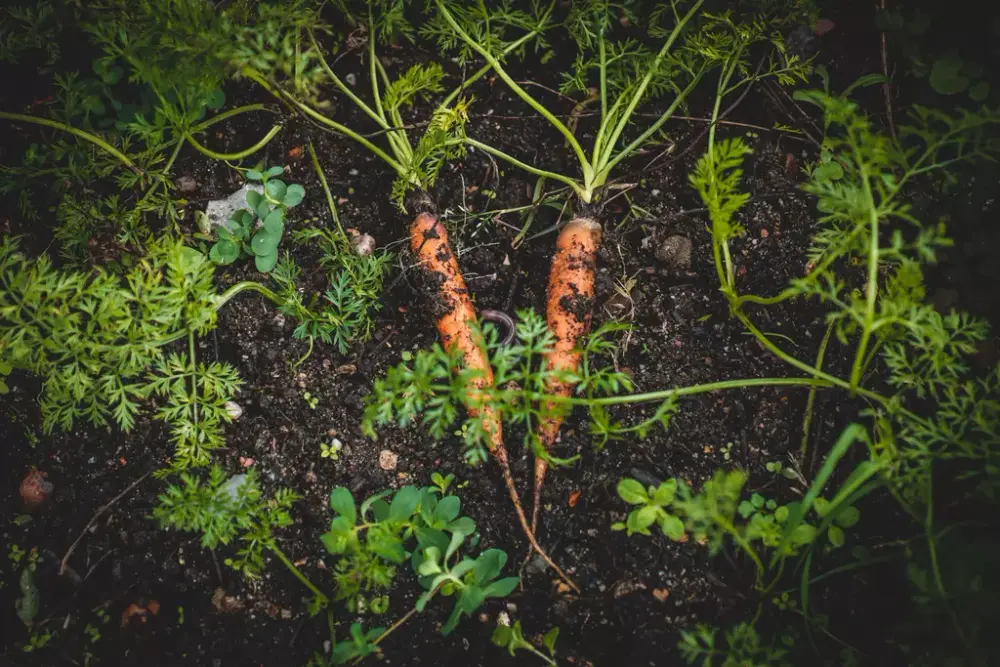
[209,167,306,273]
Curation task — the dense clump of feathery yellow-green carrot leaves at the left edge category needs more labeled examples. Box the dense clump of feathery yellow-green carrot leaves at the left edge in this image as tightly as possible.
[0,238,239,465]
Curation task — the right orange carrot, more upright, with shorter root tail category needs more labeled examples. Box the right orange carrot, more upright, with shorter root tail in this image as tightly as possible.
[531,217,601,532]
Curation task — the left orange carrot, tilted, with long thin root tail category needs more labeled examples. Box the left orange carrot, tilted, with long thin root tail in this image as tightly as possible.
[410,213,580,592]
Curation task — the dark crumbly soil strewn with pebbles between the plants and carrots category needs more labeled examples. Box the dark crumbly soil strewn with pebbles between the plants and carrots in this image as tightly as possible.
[0,2,997,667]
